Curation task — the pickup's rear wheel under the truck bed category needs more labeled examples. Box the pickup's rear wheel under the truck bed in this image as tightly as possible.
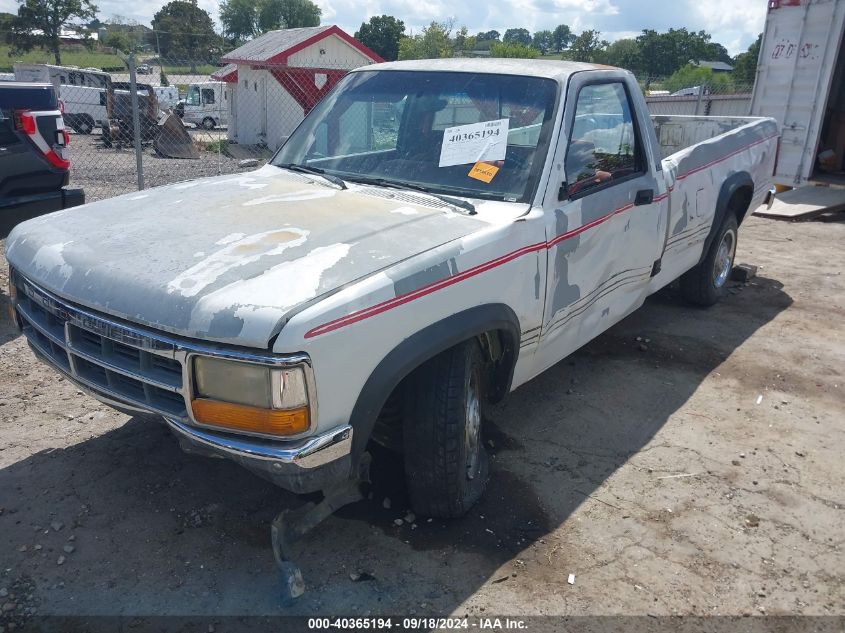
[681,213,738,307]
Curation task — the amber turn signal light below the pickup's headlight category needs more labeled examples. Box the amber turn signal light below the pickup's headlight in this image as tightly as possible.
[191,398,311,436]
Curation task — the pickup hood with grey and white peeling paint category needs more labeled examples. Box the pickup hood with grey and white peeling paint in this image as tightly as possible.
[6,166,486,348]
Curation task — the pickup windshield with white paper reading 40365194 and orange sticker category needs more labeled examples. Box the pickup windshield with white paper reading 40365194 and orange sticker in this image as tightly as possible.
[273,70,557,202]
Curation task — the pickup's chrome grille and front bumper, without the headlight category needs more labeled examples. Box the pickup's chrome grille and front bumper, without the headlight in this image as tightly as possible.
[12,273,352,493]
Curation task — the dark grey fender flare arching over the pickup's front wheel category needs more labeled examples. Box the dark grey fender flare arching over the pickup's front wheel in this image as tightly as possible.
[349,303,520,462]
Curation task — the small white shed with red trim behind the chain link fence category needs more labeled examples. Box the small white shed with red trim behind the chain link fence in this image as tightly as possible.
[211,26,382,150]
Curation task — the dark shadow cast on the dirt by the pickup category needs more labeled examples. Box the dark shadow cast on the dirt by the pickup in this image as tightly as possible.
[0,278,792,628]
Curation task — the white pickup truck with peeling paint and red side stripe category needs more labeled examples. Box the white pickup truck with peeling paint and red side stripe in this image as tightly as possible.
[7,59,778,584]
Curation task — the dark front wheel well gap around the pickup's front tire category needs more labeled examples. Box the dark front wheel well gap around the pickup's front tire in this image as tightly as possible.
[372,330,518,452]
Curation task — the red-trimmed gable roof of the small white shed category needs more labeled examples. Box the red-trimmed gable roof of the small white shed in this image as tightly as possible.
[222,25,382,64]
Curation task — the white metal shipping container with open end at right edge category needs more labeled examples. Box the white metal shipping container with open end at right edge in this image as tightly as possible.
[751,0,845,187]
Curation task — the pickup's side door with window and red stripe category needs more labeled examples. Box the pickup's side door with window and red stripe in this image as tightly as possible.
[538,73,662,368]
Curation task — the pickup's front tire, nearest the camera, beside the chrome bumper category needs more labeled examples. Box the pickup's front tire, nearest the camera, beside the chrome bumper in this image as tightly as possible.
[402,340,489,518]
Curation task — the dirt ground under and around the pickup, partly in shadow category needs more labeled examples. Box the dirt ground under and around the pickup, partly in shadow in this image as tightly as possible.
[0,215,845,631]
